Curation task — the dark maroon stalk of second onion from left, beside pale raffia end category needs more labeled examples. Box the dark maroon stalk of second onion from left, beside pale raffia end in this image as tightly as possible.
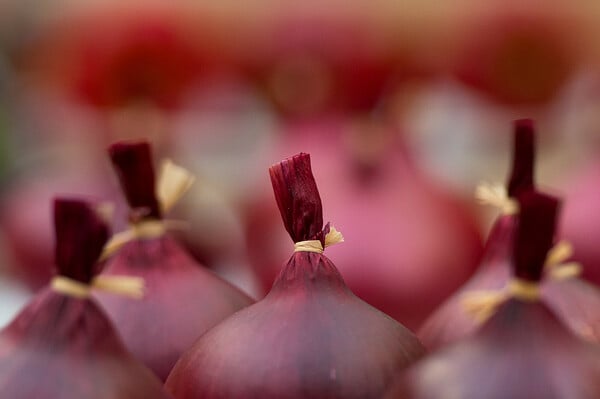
[108,141,162,222]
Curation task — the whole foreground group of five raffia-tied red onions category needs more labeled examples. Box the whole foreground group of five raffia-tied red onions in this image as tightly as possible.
[0,120,600,399]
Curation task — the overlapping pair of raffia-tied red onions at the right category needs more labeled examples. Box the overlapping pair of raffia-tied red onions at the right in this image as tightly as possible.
[386,120,600,399]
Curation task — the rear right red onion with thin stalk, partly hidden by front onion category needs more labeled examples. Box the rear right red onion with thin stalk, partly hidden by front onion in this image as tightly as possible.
[418,119,600,350]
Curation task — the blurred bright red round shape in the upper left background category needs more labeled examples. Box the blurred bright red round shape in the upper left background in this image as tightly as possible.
[20,3,211,110]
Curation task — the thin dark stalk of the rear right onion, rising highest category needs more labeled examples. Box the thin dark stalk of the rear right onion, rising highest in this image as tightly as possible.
[508,119,535,198]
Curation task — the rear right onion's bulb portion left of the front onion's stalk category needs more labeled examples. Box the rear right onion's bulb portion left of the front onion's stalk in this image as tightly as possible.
[417,215,517,351]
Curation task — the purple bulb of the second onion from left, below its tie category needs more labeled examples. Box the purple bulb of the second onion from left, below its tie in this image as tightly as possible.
[95,235,254,381]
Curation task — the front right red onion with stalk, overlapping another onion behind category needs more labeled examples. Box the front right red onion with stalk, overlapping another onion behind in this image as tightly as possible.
[386,191,600,399]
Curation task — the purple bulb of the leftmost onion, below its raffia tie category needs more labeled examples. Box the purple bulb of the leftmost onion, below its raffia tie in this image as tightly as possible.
[0,289,170,399]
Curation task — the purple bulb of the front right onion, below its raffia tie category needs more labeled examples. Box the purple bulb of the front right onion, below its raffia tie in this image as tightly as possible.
[385,300,600,399]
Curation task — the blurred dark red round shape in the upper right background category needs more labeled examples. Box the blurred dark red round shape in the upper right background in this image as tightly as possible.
[450,1,580,105]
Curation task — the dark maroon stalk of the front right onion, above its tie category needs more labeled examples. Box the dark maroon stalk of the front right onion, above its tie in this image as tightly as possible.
[513,191,560,282]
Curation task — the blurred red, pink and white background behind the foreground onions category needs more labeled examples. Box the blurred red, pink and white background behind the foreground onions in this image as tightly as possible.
[0,0,600,328]
